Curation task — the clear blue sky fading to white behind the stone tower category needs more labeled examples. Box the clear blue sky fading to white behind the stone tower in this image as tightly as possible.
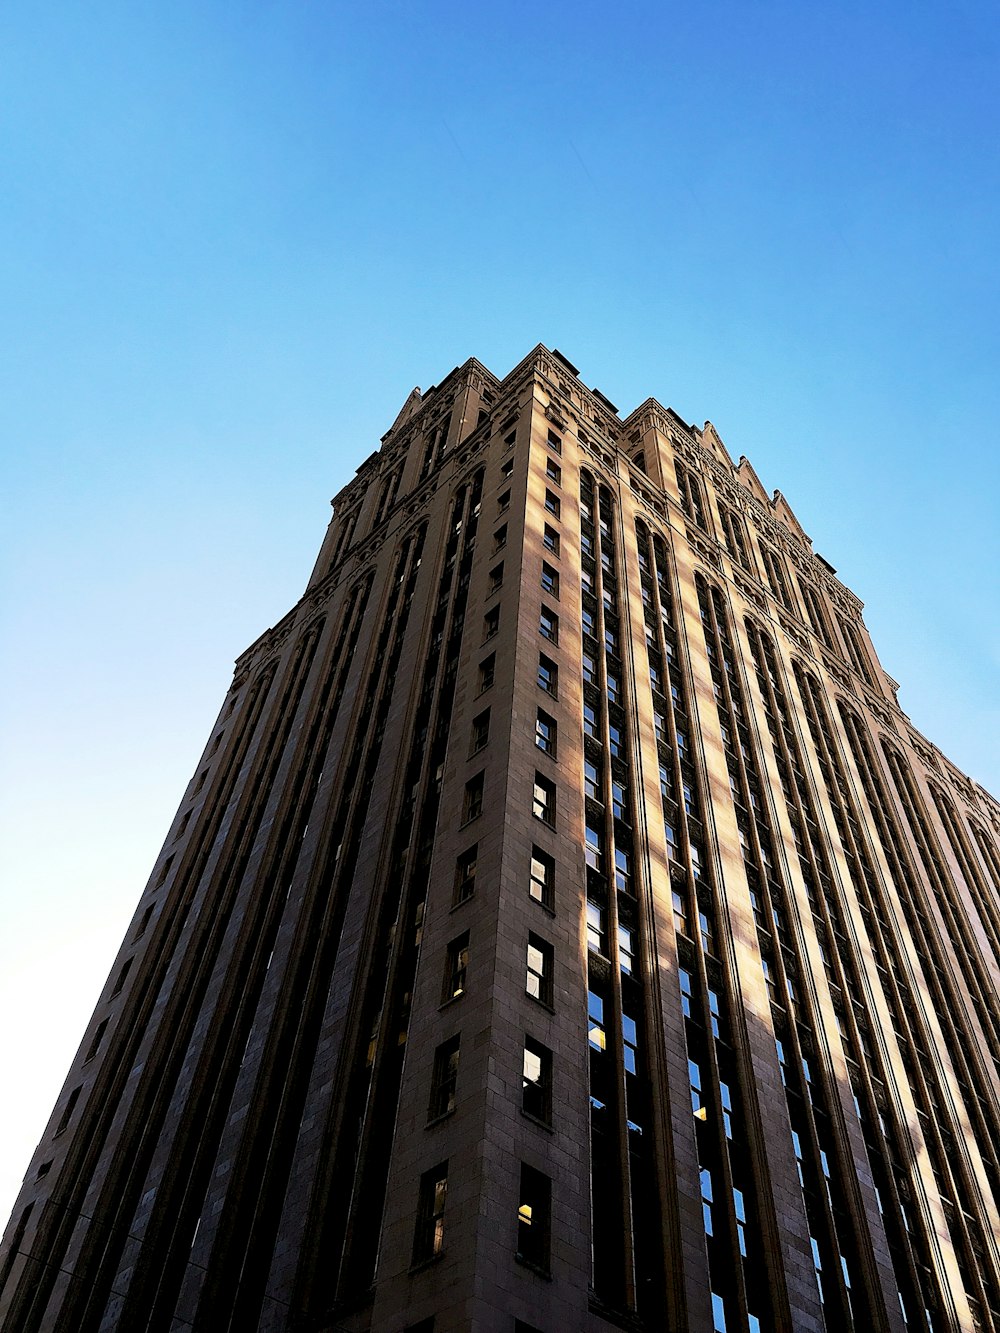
[0,0,1000,1225]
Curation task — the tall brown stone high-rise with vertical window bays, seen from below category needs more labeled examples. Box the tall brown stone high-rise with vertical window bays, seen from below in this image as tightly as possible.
[0,347,1000,1333]
